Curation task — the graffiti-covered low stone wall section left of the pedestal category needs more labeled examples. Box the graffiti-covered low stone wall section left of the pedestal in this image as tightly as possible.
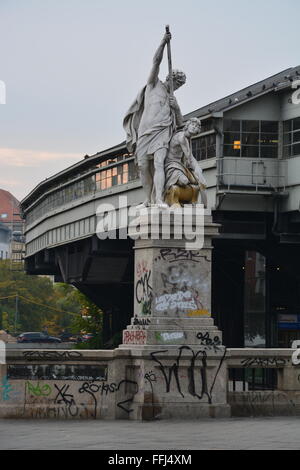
[0,349,131,419]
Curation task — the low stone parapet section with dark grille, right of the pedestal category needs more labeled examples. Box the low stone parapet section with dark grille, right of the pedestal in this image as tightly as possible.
[227,349,300,416]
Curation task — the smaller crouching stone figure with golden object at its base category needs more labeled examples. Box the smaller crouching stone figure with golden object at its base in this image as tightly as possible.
[165,118,207,207]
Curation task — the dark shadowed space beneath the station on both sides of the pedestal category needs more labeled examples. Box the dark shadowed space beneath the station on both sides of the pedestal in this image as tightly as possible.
[26,211,300,348]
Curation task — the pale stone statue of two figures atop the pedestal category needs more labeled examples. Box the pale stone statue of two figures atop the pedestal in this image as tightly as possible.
[124,27,207,208]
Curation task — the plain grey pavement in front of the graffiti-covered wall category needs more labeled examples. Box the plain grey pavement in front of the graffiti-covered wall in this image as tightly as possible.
[0,417,300,451]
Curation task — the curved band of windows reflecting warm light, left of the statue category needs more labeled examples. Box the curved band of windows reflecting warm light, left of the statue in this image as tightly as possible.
[26,154,138,224]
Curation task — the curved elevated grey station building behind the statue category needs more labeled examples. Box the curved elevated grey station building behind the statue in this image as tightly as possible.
[21,66,300,348]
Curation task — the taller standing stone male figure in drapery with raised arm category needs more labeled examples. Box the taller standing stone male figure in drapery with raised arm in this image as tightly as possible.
[124,33,186,207]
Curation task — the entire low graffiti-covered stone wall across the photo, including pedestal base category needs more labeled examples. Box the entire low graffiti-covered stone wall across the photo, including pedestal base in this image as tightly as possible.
[0,346,300,420]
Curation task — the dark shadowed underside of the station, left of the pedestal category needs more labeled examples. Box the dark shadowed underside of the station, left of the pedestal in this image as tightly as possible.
[25,236,134,344]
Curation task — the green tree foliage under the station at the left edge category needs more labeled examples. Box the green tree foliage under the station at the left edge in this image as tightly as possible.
[0,260,103,349]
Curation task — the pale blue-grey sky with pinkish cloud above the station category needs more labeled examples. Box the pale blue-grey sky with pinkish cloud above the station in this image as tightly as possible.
[0,0,300,200]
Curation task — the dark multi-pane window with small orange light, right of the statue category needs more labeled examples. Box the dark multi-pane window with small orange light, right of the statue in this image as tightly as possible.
[223,119,279,158]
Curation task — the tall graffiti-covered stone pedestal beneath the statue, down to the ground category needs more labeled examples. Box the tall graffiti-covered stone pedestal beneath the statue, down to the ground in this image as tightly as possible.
[120,209,230,419]
